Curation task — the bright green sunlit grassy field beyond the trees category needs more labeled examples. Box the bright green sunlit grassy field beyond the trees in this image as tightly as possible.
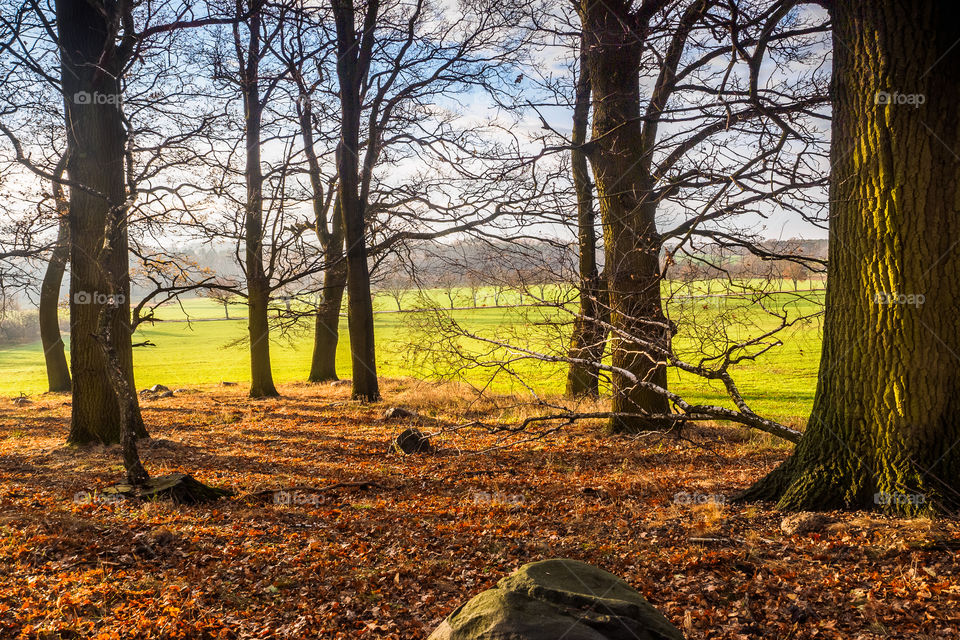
[0,283,822,426]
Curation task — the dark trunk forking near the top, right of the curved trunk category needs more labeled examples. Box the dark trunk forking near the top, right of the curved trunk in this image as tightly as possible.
[331,0,380,402]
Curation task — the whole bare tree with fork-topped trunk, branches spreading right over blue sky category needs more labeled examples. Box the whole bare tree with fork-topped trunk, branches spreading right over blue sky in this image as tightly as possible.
[298,0,542,398]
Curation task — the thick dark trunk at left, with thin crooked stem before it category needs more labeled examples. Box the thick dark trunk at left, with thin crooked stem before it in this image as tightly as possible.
[56,0,147,444]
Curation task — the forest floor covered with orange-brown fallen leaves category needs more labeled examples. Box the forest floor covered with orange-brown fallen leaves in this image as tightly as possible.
[0,381,960,640]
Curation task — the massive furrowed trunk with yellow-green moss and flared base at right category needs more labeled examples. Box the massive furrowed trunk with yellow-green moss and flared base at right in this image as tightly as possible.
[743,0,960,514]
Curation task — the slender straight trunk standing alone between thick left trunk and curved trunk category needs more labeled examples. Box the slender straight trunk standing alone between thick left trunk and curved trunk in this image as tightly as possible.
[243,3,280,398]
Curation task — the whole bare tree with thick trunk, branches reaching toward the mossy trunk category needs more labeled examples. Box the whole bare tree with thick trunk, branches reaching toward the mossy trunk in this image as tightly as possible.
[579,0,825,432]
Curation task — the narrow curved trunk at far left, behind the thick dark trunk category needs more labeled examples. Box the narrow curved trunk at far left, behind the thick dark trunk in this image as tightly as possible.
[39,162,71,392]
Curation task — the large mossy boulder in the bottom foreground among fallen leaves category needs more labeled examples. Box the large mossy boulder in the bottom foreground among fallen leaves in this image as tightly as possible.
[428,558,683,640]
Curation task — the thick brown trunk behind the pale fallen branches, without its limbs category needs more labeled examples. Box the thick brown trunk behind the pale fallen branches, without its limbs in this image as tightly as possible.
[582,0,670,433]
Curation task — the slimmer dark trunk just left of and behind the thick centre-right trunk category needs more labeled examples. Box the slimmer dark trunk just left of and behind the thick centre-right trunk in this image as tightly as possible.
[568,28,606,397]
